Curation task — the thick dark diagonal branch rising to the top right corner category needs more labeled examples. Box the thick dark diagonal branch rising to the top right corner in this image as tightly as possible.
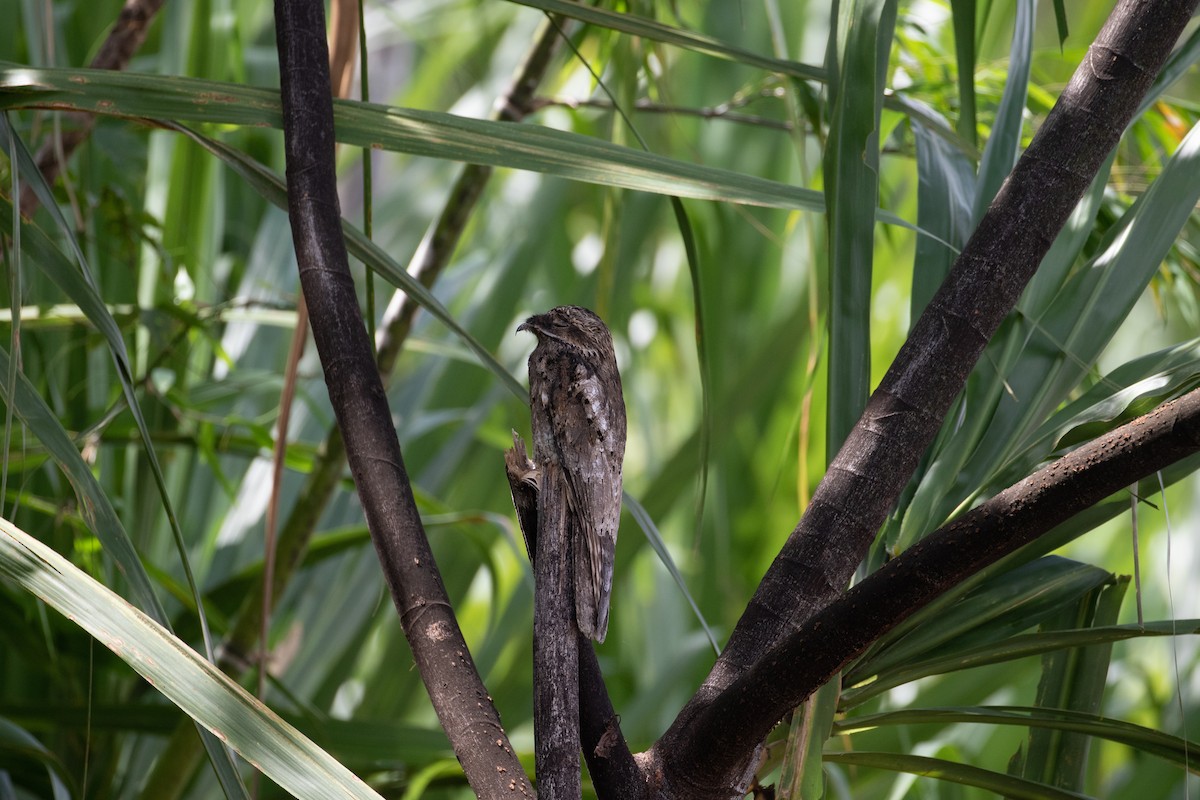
[649,0,1196,796]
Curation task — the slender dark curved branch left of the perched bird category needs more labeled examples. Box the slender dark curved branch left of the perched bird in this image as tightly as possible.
[275,0,533,798]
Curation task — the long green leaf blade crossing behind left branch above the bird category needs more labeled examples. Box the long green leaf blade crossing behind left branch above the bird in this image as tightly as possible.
[0,67,825,215]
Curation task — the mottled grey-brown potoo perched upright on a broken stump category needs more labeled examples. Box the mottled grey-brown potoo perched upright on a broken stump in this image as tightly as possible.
[517,306,625,642]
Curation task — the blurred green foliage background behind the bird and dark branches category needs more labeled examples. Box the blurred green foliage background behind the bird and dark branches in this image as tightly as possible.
[0,0,1200,798]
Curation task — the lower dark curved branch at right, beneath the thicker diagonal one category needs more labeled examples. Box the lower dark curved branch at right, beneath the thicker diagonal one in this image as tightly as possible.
[678,390,1200,782]
